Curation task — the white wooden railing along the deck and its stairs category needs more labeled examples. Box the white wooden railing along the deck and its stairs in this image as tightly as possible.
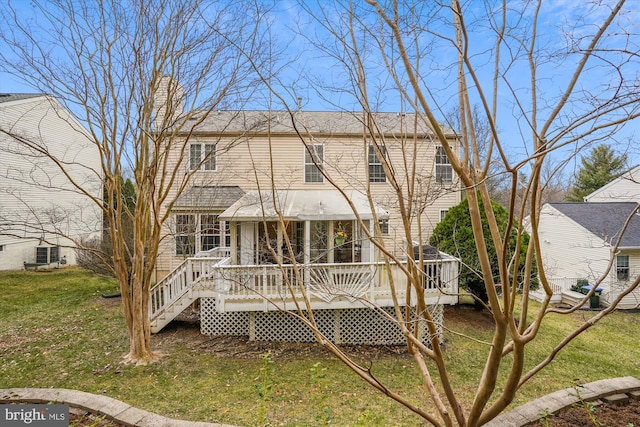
[150,257,458,318]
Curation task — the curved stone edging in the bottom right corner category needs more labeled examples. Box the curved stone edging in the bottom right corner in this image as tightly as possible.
[485,377,640,427]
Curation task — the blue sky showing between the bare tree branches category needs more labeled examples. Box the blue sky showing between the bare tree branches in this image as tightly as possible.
[0,0,640,175]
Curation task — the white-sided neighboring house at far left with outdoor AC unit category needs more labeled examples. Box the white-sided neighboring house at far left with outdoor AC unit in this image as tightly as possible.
[0,94,102,270]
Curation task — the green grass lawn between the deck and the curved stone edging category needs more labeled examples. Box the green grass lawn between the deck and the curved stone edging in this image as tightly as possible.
[0,268,640,426]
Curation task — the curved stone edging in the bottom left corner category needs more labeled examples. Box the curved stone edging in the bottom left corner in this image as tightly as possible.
[0,388,240,427]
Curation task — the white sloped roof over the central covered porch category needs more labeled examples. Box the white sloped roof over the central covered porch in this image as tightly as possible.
[219,190,389,221]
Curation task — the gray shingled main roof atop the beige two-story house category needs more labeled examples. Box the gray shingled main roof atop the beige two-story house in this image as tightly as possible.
[188,110,455,137]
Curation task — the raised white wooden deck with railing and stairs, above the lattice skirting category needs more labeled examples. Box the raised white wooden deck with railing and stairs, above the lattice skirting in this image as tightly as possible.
[149,257,458,332]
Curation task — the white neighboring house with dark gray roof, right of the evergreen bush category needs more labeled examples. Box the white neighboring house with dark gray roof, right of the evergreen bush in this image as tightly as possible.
[532,201,640,308]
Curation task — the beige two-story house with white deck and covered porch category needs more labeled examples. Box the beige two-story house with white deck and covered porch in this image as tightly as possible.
[150,105,461,344]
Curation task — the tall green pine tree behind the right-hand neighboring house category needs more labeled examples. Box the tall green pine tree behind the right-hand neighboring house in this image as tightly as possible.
[567,145,627,202]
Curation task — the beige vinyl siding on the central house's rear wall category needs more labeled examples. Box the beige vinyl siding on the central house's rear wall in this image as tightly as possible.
[158,125,461,277]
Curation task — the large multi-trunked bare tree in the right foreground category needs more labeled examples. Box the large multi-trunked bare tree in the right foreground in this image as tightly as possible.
[250,0,640,426]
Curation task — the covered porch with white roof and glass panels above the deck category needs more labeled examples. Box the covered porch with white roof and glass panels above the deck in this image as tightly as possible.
[220,190,389,265]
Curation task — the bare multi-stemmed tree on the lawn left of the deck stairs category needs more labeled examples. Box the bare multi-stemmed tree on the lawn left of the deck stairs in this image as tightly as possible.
[0,0,266,363]
